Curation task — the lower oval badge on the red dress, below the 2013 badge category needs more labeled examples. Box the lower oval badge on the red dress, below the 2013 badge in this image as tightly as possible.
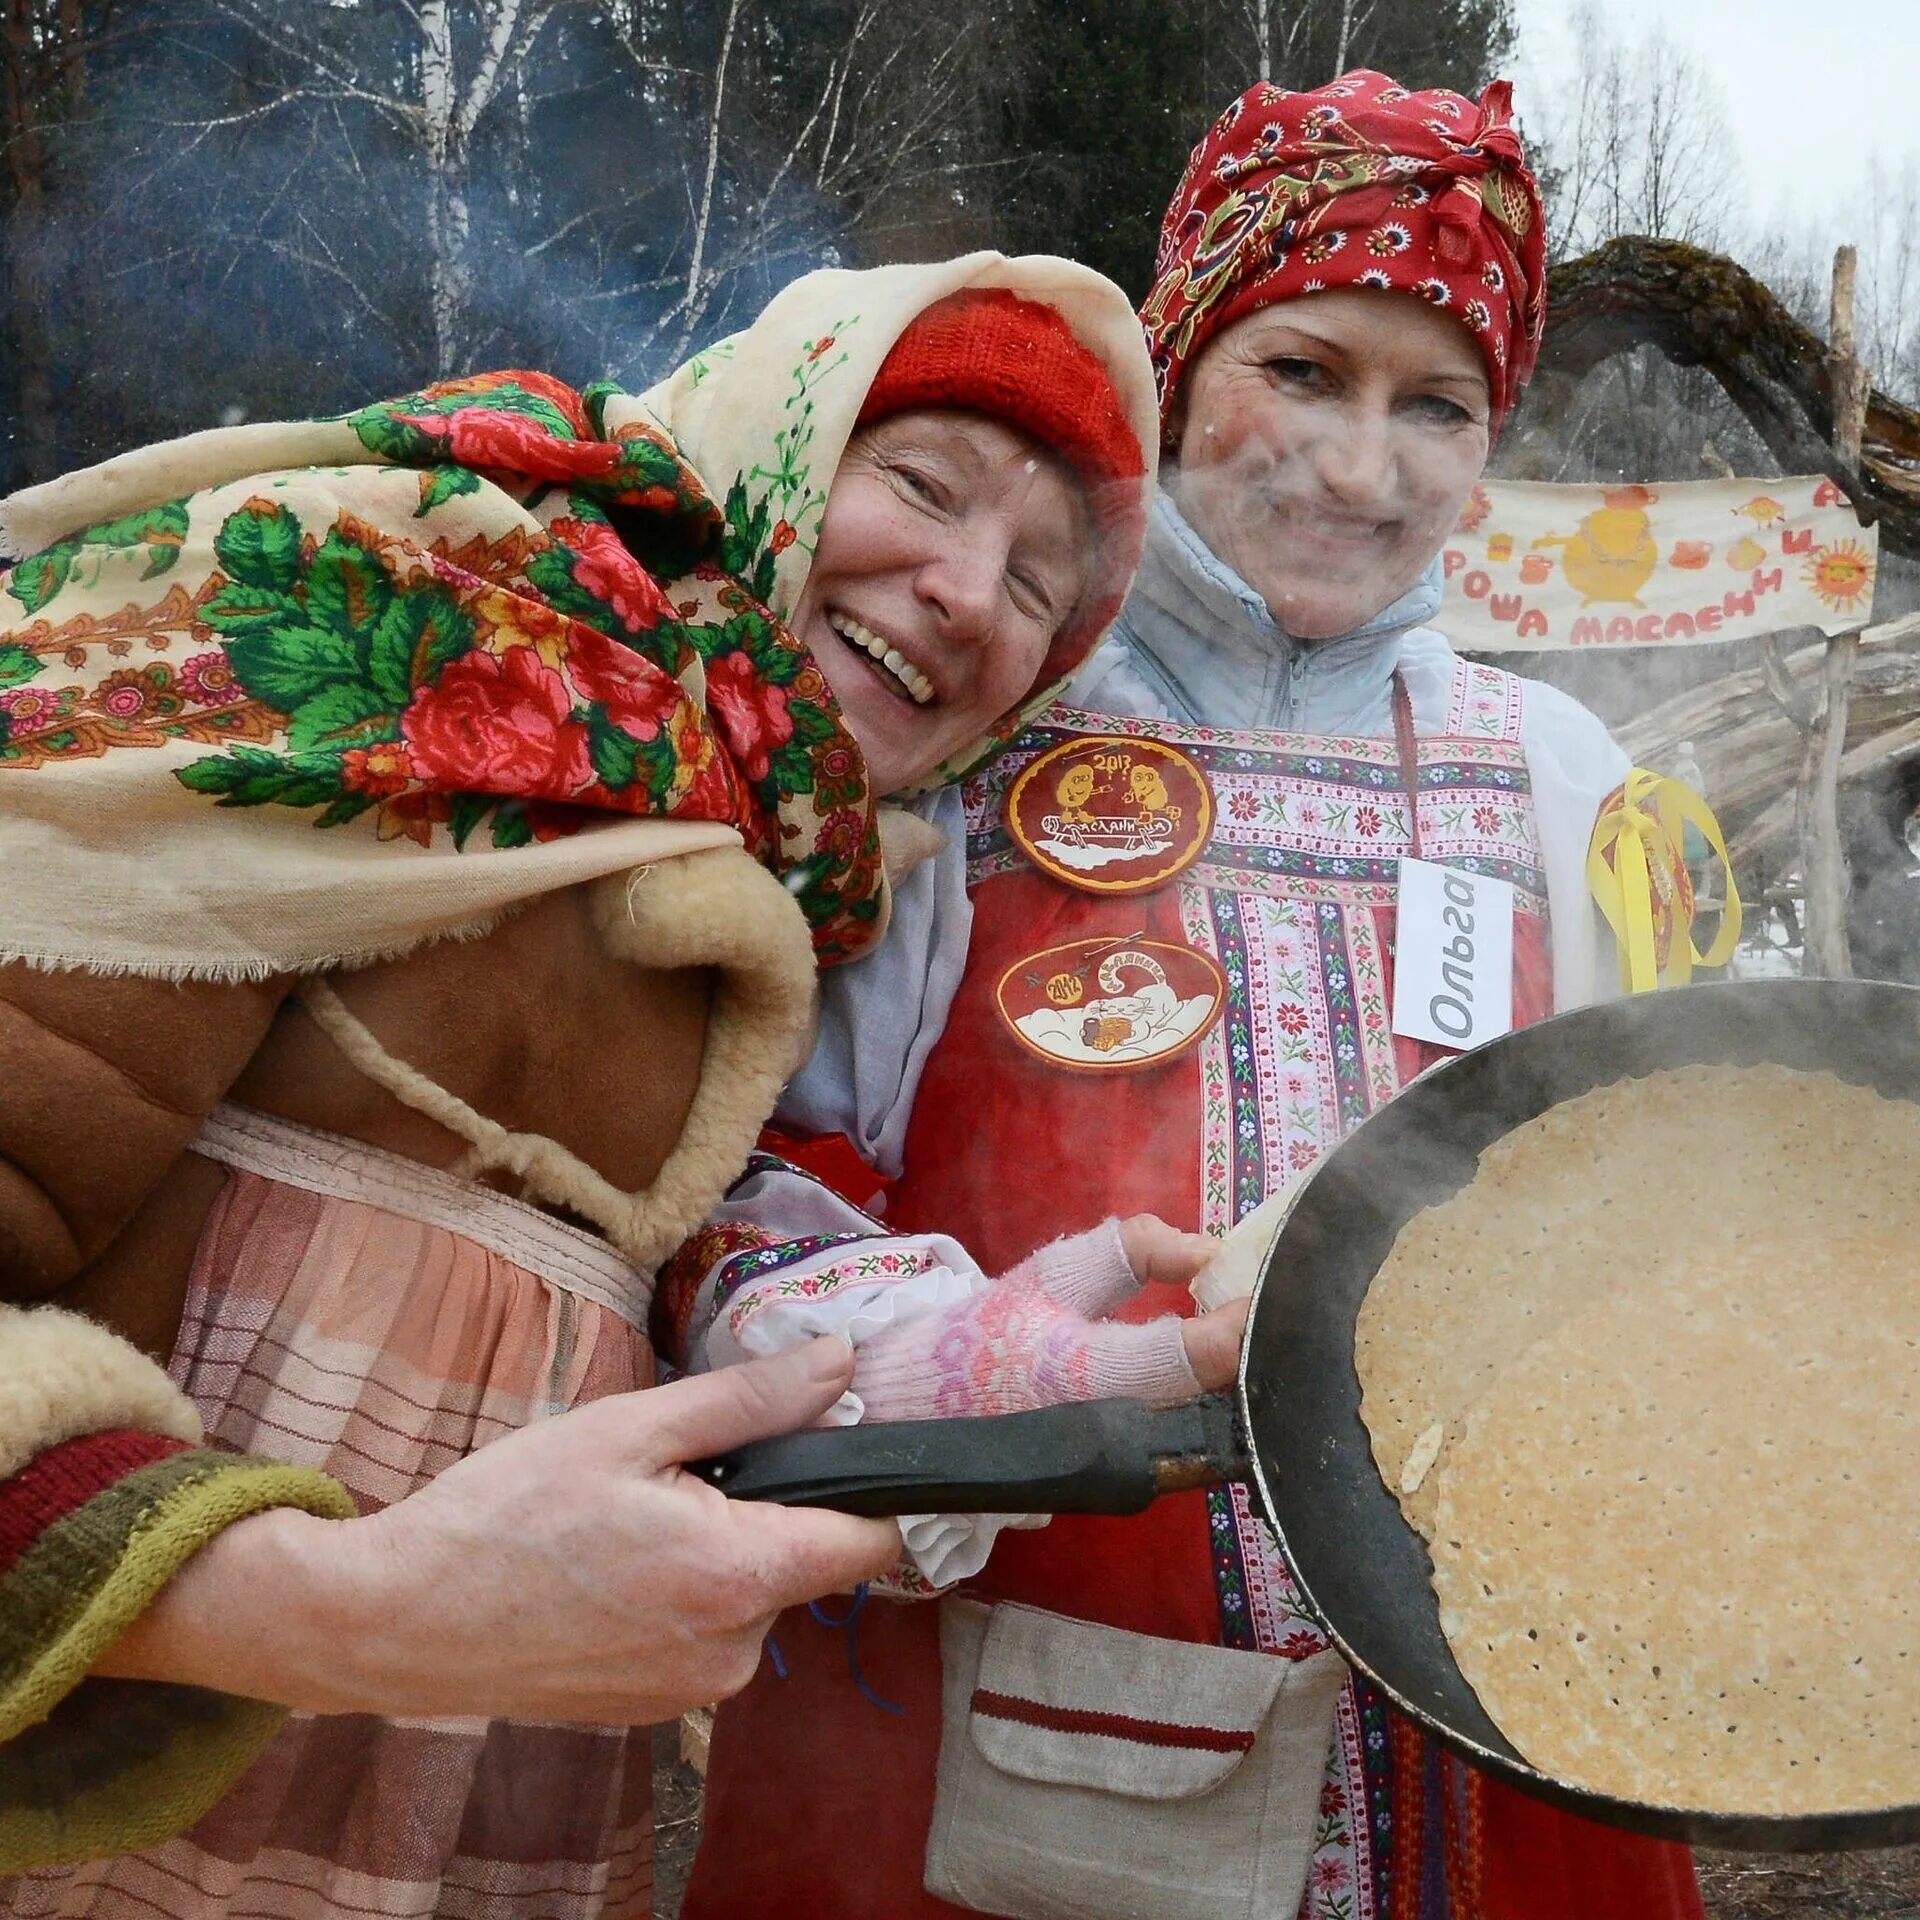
[993,933,1227,1073]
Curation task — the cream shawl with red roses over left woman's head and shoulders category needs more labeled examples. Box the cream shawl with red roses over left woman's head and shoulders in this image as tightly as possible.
[0,253,1152,979]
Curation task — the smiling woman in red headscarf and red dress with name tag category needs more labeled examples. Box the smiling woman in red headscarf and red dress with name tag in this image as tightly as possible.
[685,73,1699,1920]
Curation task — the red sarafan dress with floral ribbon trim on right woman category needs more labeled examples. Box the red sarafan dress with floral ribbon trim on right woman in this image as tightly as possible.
[684,662,1701,1920]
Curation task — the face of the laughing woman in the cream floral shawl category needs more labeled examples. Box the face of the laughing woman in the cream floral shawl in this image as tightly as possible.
[793,409,1092,793]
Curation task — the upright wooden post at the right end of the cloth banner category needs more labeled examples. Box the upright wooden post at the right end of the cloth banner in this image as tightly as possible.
[1793,246,1868,979]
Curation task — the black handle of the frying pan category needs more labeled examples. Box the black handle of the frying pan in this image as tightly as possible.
[687,1394,1250,1517]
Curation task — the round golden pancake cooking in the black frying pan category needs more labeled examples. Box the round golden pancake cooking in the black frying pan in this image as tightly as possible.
[1356,1066,1920,1814]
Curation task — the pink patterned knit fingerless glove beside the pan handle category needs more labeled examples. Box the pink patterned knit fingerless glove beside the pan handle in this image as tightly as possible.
[852,1219,1200,1421]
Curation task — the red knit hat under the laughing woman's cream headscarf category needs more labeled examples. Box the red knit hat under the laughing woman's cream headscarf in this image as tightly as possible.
[854,286,1146,685]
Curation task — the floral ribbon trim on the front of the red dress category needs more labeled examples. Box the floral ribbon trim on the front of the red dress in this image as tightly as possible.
[966,662,1546,1920]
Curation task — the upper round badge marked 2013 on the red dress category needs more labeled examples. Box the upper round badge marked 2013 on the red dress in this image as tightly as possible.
[1006,733,1213,893]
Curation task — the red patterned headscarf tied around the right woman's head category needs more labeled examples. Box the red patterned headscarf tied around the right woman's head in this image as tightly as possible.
[1140,71,1546,430]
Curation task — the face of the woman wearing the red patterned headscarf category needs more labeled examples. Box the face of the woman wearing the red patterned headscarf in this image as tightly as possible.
[1171,288,1492,639]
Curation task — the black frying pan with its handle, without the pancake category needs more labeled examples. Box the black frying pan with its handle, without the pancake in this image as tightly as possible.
[707,981,1920,1851]
